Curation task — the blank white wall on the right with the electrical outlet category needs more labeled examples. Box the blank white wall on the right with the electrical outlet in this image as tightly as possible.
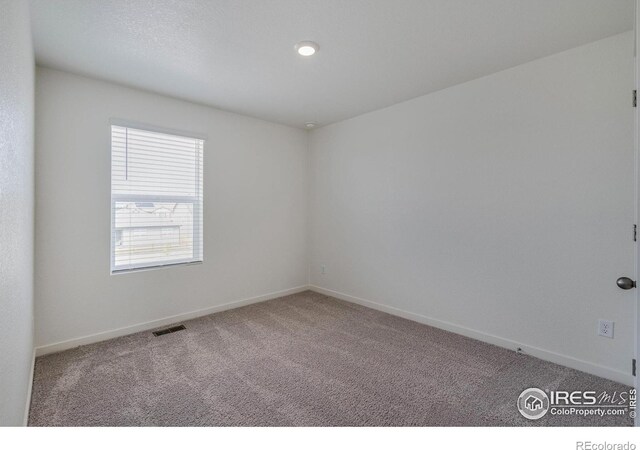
[310,32,635,384]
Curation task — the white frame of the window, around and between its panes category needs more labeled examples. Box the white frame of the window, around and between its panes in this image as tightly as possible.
[108,119,207,275]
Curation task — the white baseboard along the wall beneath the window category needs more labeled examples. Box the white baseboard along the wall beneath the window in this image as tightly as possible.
[35,286,309,356]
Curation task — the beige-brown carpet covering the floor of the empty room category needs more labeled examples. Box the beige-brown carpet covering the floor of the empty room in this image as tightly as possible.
[29,291,632,426]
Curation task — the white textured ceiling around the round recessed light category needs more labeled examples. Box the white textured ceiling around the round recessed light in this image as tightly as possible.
[31,0,634,127]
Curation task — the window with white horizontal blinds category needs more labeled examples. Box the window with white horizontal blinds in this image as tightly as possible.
[111,125,204,273]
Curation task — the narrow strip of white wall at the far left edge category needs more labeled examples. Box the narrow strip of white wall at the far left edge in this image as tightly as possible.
[0,0,34,426]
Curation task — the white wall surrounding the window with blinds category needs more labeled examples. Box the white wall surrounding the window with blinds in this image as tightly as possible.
[35,68,308,351]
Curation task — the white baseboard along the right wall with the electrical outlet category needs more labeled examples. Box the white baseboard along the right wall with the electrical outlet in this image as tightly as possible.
[309,285,634,386]
